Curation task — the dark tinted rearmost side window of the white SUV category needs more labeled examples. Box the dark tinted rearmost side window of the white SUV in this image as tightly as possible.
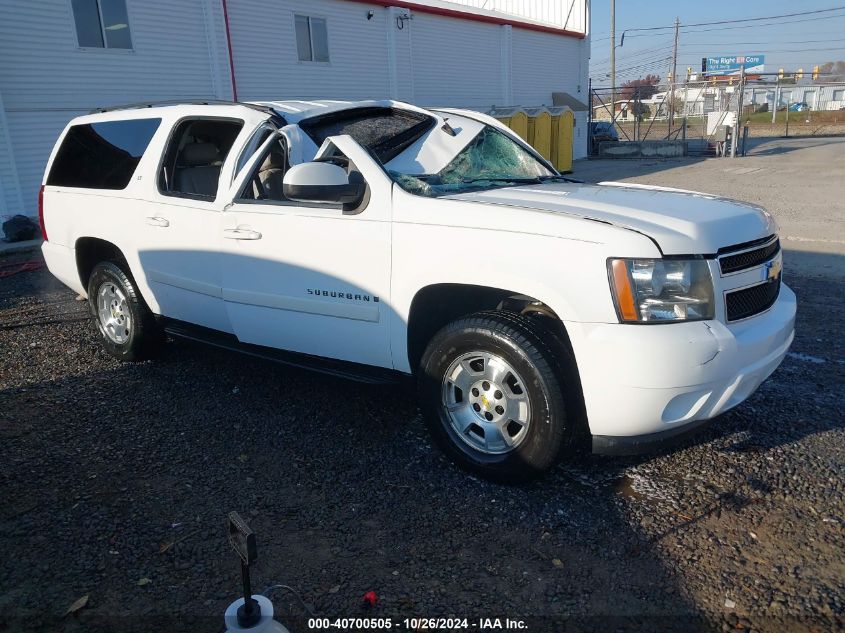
[47,119,161,189]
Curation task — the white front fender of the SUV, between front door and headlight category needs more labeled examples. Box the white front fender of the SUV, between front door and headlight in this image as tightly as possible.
[391,188,659,371]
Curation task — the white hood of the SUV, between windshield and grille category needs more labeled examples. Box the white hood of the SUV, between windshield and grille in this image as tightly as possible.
[444,182,777,255]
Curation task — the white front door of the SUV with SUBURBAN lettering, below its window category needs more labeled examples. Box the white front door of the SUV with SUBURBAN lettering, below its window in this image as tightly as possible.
[220,139,392,367]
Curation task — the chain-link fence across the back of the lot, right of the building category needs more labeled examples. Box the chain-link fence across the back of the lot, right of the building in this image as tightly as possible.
[590,78,845,156]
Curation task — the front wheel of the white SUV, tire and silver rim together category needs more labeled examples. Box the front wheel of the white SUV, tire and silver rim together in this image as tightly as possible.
[418,312,570,483]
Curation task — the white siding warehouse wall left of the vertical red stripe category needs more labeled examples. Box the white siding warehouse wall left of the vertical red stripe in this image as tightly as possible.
[0,0,232,220]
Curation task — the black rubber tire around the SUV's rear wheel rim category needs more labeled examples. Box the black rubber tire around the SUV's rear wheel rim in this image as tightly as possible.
[88,261,164,362]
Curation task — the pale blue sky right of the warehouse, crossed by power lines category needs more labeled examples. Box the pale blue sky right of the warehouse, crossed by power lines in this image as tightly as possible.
[590,0,845,86]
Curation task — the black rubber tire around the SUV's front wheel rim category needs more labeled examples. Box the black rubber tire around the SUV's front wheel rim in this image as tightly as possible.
[417,311,577,483]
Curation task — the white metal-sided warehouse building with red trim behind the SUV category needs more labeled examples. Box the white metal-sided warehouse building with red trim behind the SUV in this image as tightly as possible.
[0,0,590,227]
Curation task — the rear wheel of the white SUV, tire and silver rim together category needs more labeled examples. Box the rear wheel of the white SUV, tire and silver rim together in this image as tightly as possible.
[88,261,164,361]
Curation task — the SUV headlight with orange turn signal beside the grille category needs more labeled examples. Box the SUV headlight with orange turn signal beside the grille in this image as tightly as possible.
[608,259,713,323]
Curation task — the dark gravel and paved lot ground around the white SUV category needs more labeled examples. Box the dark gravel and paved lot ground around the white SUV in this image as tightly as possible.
[0,139,845,632]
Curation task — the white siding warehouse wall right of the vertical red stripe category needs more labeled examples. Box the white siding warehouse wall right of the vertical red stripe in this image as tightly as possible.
[229,0,589,153]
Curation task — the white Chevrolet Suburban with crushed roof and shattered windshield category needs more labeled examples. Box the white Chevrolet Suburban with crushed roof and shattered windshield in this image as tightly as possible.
[39,101,796,481]
